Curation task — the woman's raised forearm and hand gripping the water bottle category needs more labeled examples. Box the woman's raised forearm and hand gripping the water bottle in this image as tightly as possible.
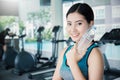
[66,45,86,80]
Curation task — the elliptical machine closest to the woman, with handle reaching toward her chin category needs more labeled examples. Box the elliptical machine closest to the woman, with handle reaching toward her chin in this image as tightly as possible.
[28,26,72,80]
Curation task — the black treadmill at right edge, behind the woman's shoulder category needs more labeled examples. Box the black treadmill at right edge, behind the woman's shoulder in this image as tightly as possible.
[100,28,120,80]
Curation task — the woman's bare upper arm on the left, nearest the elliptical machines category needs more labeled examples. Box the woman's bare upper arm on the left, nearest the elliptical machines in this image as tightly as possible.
[52,48,67,80]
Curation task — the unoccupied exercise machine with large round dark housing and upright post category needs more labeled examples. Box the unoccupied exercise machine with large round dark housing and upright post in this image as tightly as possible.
[13,34,35,75]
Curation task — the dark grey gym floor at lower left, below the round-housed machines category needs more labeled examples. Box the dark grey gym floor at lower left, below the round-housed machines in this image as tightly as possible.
[0,62,49,80]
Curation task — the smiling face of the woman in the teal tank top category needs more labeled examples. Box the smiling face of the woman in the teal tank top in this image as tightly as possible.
[66,12,90,42]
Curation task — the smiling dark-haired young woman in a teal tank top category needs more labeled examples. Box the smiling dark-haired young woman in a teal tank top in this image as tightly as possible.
[53,3,104,80]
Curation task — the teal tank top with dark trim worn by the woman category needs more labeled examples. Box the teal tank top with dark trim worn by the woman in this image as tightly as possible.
[60,43,98,80]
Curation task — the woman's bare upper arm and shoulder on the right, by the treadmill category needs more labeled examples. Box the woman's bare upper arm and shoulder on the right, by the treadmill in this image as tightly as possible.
[88,48,104,80]
